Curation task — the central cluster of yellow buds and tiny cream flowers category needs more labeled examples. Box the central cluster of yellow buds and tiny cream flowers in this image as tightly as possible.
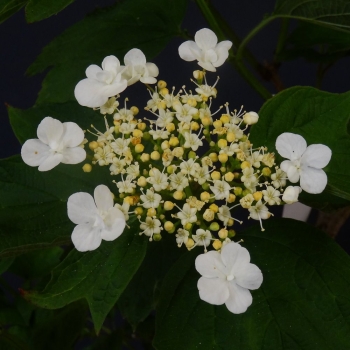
[84,71,287,251]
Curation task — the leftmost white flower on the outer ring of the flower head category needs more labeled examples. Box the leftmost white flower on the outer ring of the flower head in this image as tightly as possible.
[21,117,86,171]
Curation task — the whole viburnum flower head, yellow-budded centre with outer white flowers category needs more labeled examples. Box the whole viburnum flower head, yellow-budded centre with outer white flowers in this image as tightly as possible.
[21,28,332,314]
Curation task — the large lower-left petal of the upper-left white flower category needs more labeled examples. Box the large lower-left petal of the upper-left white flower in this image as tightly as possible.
[74,79,113,108]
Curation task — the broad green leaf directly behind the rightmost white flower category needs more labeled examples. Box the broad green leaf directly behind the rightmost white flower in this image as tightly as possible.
[250,87,350,209]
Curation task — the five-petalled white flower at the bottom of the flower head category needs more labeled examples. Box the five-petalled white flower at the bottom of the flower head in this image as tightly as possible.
[195,242,263,314]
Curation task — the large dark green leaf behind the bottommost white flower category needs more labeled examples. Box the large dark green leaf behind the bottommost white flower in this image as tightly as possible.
[154,219,350,350]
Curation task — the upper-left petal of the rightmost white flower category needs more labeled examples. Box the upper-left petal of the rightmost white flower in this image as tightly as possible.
[276,132,306,160]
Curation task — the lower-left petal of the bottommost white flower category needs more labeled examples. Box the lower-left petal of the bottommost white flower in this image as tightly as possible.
[197,277,229,305]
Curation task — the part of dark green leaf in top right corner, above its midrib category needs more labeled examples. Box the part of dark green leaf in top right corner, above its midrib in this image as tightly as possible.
[273,0,350,29]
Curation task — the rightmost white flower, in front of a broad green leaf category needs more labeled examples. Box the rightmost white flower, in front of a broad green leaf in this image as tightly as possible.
[276,132,332,193]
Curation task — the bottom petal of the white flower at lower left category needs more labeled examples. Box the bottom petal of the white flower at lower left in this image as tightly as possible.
[72,224,102,252]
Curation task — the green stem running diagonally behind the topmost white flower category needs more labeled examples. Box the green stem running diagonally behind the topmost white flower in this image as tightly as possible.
[196,0,271,100]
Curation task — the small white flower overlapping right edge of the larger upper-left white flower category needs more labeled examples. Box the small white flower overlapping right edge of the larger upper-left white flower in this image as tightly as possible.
[122,49,159,86]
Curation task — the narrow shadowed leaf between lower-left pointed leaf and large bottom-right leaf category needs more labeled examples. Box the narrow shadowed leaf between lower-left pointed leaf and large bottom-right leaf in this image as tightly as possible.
[118,233,187,329]
